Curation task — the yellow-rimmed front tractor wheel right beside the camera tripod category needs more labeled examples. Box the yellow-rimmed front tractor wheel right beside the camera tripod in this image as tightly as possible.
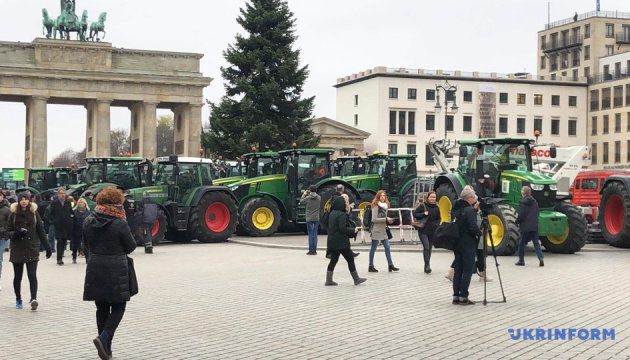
[486,205,519,256]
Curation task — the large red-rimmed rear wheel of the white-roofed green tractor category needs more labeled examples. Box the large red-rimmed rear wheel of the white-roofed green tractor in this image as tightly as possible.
[187,191,238,243]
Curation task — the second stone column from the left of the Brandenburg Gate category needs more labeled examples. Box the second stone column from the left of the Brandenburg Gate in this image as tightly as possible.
[85,99,112,157]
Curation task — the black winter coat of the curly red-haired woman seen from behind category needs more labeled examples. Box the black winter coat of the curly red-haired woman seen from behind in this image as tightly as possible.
[83,212,136,304]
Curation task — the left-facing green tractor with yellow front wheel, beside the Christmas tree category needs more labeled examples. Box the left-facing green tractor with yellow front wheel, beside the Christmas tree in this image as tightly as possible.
[230,149,360,237]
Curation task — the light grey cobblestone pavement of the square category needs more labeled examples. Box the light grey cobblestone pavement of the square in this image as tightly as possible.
[0,237,630,359]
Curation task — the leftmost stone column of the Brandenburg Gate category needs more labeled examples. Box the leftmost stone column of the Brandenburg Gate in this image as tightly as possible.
[24,96,48,169]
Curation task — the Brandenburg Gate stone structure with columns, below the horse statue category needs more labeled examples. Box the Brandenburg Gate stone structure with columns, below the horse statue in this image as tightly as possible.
[0,38,212,168]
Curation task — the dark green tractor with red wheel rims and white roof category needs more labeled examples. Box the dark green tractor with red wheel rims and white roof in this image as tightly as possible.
[129,155,238,244]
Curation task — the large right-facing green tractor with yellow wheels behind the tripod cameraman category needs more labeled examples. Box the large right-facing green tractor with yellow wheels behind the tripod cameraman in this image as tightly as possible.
[430,138,588,255]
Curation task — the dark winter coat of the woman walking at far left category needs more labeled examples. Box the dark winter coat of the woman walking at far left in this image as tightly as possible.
[4,203,50,264]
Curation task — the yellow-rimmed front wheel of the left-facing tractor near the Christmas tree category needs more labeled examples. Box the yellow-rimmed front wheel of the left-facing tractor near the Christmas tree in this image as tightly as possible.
[241,198,281,237]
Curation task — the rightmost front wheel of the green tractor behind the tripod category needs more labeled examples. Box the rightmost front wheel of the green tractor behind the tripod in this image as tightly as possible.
[540,201,588,254]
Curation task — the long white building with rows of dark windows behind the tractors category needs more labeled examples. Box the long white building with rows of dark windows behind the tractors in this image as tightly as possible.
[335,67,588,172]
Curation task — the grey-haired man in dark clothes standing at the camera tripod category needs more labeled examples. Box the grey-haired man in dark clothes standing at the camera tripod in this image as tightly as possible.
[451,189,481,305]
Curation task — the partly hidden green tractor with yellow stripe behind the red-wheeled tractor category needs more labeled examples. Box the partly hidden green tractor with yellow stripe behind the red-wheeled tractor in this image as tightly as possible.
[213,152,281,186]
